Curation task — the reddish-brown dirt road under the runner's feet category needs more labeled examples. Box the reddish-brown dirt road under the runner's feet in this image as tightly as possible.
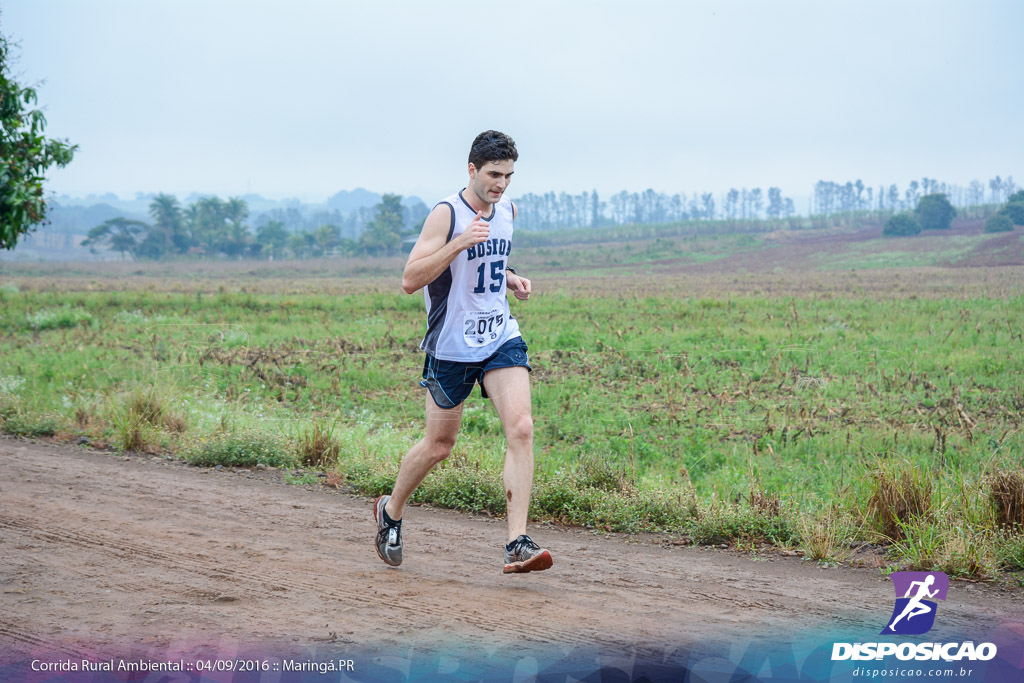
[0,437,1024,671]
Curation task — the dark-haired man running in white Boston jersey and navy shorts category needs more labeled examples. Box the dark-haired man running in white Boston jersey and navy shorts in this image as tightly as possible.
[374,130,552,573]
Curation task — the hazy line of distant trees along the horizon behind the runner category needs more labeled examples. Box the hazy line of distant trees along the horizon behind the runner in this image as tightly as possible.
[72,176,1021,259]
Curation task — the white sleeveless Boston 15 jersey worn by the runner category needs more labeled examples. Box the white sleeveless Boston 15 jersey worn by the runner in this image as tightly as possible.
[420,193,520,362]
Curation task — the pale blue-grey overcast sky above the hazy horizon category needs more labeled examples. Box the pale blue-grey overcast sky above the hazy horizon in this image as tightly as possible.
[0,0,1024,202]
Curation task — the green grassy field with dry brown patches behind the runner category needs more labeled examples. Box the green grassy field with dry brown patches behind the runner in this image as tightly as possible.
[0,236,1024,577]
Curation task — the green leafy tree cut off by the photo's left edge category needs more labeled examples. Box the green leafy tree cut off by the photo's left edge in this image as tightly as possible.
[0,29,78,249]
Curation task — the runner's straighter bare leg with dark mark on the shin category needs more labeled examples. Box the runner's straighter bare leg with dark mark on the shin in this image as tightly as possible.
[481,367,534,542]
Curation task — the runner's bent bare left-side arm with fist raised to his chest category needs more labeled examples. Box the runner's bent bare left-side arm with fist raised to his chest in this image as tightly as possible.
[401,204,490,294]
